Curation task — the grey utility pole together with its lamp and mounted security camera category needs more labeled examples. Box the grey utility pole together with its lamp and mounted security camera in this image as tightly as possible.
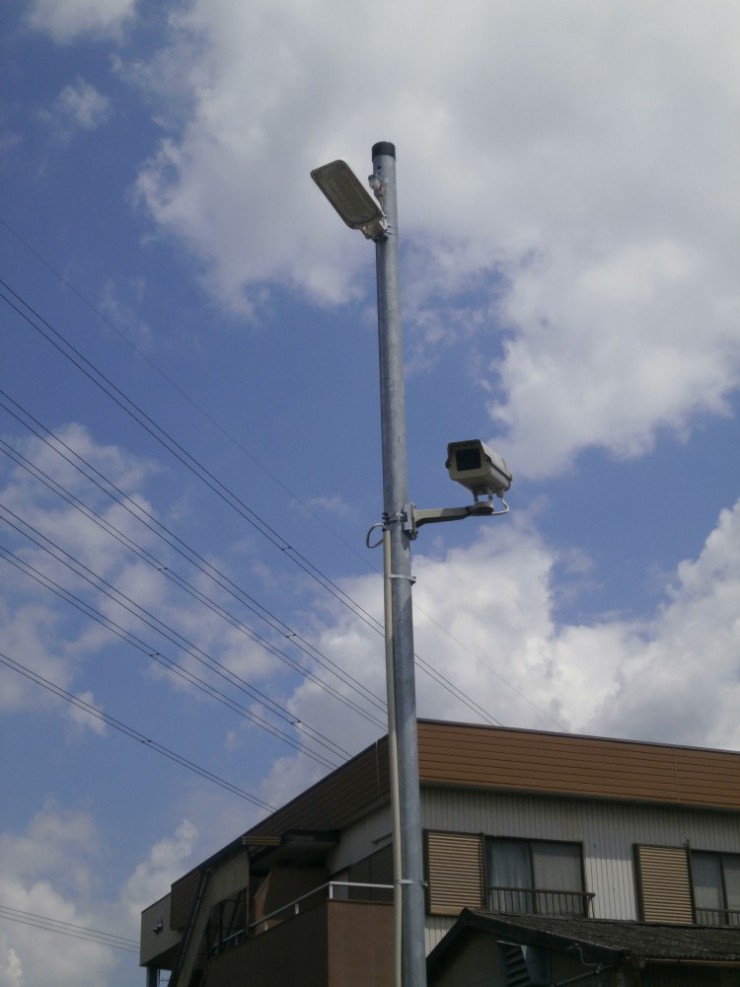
[311,141,512,987]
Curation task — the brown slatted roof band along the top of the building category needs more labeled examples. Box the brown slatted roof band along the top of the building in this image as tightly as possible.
[246,720,740,837]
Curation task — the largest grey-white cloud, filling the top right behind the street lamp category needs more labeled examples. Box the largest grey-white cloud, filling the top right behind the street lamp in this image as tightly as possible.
[133,0,740,475]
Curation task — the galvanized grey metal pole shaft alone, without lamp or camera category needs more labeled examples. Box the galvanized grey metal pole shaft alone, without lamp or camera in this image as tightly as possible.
[372,141,427,987]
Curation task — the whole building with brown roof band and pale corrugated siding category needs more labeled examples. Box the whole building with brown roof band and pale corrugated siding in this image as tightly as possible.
[141,720,740,987]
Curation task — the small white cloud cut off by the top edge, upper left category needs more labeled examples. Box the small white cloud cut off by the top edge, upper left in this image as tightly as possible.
[28,0,137,44]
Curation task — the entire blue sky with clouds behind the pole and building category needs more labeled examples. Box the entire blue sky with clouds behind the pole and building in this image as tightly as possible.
[0,0,740,987]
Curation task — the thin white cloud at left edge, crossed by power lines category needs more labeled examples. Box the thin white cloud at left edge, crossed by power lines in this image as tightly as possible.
[0,425,160,712]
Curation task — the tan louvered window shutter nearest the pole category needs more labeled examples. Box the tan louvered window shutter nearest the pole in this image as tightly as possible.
[427,832,483,915]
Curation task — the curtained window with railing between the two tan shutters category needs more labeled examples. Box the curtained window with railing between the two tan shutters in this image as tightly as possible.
[486,838,593,915]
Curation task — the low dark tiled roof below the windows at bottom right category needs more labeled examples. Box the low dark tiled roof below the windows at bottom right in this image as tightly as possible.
[428,909,740,971]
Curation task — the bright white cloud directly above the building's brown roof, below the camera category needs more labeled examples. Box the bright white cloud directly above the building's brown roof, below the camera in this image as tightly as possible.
[272,501,740,760]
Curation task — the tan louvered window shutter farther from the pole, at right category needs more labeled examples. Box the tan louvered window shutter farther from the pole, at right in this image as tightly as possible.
[636,846,694,925]
